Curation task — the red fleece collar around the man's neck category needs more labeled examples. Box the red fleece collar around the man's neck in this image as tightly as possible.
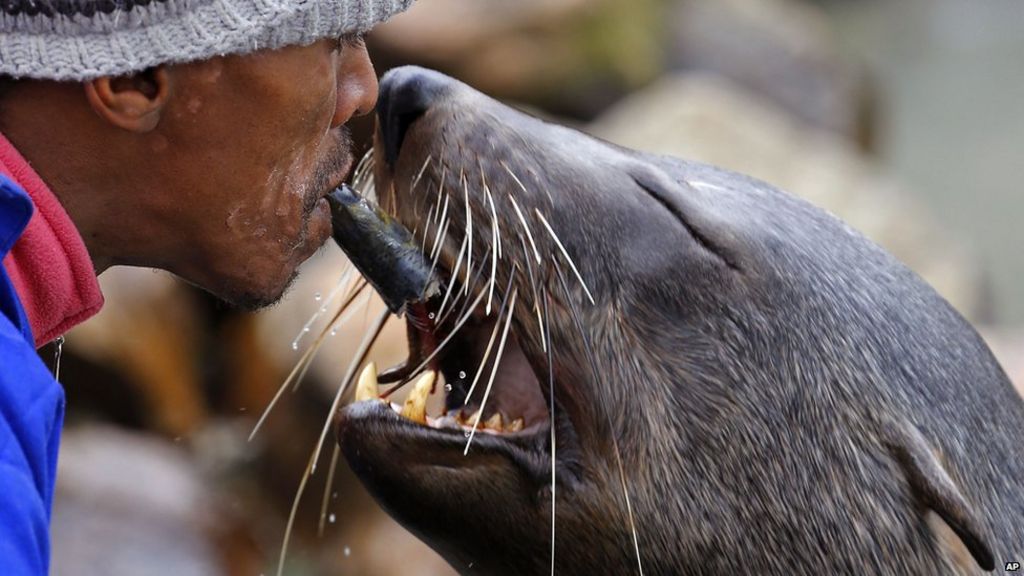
[0,134,103,347]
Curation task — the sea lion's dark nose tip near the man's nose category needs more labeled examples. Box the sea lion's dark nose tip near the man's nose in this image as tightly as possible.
[377,66,447,166]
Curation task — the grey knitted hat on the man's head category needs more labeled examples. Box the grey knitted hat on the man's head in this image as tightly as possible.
[0,0,414,81]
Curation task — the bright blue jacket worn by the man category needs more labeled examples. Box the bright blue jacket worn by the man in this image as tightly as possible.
[0,175,65,576]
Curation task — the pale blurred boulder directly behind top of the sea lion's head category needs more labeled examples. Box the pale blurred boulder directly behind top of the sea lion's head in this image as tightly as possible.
[590,74,981,318]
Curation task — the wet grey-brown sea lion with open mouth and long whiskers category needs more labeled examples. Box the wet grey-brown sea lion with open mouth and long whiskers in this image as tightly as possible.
[337,68,1024,575]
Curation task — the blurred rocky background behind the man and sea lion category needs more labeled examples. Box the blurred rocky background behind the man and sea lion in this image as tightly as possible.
[40,0,1024,576]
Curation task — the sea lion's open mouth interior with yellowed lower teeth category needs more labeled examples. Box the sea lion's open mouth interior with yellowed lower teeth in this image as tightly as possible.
[343,215,550,472]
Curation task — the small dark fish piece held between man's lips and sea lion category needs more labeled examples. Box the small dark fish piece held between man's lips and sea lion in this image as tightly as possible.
[327,184,438,315]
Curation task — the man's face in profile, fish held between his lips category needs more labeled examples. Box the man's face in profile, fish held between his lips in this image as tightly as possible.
[149,40,377,307]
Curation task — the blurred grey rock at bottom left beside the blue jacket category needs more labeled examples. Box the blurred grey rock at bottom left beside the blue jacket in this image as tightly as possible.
[52,426,224,576]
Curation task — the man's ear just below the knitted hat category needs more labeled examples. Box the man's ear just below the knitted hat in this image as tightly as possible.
[85,67,171,133]
